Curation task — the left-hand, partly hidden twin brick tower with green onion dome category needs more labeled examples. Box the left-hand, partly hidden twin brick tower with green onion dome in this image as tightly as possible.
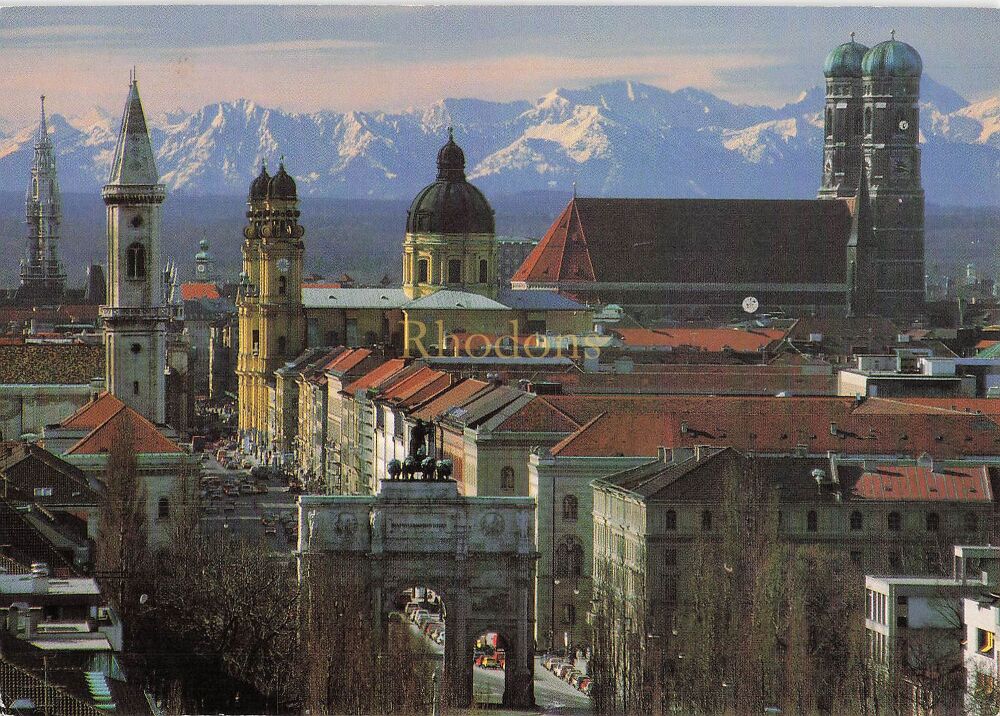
[819,32,868,199]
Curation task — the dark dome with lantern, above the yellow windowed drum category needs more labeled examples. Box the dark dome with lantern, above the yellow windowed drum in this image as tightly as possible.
[406,128,494,234]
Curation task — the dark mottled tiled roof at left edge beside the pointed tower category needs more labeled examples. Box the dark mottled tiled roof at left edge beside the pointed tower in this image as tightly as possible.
[0,343,104,385]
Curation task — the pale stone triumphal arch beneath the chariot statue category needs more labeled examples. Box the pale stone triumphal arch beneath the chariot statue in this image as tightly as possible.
[299,471,538,708]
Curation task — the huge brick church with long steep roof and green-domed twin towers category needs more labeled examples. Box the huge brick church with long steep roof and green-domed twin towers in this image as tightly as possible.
[512,32,924,320]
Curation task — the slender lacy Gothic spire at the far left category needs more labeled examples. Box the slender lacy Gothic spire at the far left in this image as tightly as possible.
[17,95,66,306]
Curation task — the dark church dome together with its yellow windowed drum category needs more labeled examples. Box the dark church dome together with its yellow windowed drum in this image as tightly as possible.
[403,127,498,298]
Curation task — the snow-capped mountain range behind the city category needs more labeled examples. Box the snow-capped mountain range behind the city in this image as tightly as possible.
[0,77,1000,205]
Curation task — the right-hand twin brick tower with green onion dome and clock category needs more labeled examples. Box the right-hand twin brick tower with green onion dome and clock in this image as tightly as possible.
[861,31,924,318]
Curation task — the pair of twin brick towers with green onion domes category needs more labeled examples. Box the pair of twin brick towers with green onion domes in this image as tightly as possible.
[819,31,924,319]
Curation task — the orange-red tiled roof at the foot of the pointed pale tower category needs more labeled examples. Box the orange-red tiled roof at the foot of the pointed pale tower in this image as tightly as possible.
[62,393,183,455]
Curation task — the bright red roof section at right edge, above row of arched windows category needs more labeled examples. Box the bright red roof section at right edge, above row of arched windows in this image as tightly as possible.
[852,465,993,502]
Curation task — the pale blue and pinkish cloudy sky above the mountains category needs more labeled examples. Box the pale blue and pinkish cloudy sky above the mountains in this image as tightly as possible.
[0,5,1000,129]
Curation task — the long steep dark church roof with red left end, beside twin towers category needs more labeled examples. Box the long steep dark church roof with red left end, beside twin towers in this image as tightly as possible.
[512,198,851,284]
